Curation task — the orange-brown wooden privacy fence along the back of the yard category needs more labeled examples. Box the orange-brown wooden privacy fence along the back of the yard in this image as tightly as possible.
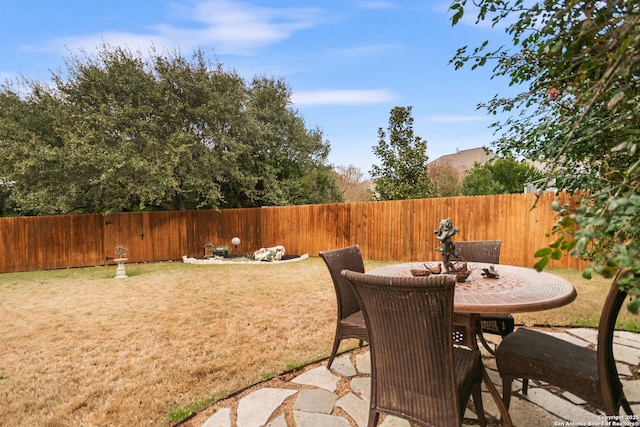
[0,193,585,273]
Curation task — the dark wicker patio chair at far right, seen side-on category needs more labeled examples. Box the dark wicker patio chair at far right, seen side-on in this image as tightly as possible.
[496,273,637,425]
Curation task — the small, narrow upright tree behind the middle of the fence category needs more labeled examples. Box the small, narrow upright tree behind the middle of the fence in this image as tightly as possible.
[369,107,433,200]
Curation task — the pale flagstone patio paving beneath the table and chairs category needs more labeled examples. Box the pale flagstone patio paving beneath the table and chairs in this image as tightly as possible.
[202,328,640,427]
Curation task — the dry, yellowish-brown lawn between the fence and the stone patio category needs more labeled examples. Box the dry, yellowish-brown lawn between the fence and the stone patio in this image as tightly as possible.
[0,257,633,427]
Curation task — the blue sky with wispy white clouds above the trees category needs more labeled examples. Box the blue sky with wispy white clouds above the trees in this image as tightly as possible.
[0,0,508,174]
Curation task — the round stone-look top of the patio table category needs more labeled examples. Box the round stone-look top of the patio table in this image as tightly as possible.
[367,261,577,313]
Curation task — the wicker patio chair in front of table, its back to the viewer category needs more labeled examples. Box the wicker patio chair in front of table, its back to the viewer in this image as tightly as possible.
[342,271,486,427]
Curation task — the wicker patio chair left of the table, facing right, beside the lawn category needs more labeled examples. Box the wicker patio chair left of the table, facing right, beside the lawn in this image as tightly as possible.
[319,245,369,369]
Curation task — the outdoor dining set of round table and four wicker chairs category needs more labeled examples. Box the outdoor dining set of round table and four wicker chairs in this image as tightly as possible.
[319,220,637,427]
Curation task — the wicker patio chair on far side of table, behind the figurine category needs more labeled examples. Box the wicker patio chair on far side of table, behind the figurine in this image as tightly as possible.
[454,240,515,353]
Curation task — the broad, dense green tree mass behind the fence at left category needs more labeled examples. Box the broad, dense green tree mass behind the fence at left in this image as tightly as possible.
[0,45,341,214]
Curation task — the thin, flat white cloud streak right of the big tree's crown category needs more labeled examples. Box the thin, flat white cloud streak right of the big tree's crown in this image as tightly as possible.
[291,89,395,105]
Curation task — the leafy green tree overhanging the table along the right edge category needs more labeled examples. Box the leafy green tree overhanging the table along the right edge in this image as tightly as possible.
[451,0,640,311]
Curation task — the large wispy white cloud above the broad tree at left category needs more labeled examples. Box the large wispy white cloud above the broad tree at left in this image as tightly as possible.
[25,0,325,55]
